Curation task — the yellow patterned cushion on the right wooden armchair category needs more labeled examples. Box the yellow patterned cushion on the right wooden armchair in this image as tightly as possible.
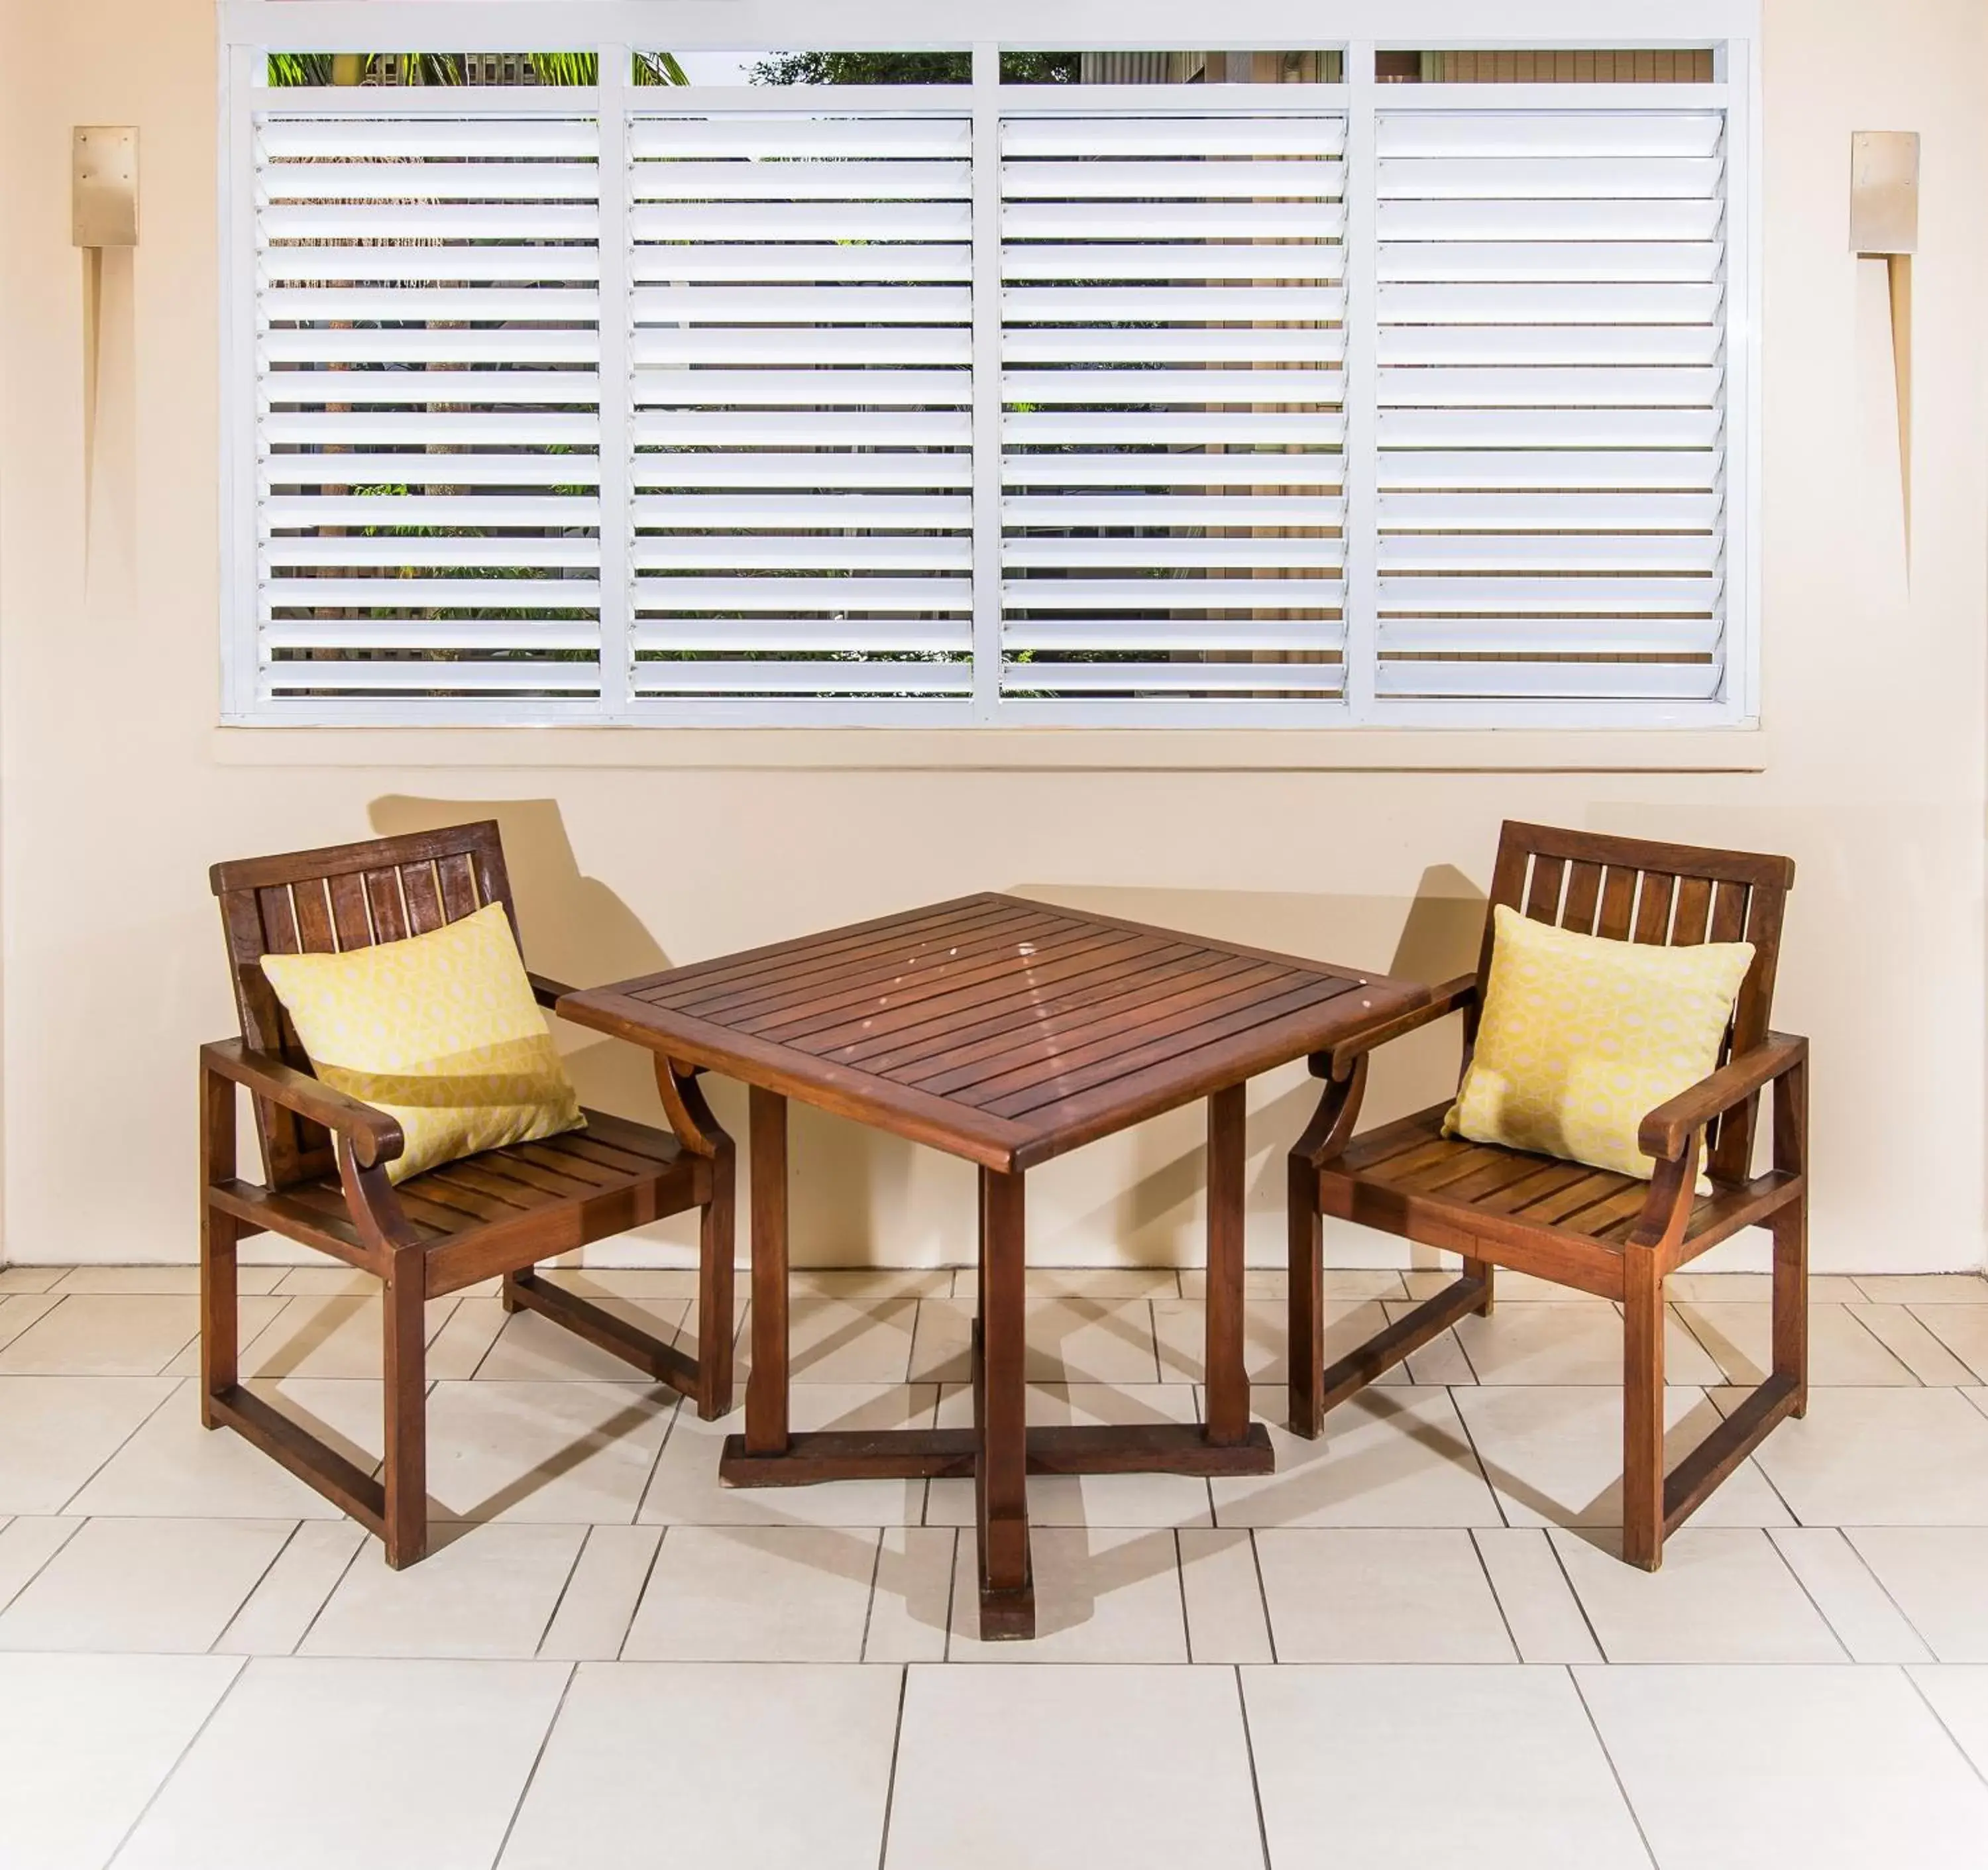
[1443,907,1753,1178]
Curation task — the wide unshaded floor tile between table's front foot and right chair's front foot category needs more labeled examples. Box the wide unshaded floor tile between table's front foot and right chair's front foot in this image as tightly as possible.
[1256,1526,1515,1663]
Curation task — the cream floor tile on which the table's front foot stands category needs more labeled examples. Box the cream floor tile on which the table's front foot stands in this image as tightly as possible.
[946,1526,1187,1663]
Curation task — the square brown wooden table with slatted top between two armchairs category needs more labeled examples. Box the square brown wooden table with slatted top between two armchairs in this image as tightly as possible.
[559,895,1427,1637]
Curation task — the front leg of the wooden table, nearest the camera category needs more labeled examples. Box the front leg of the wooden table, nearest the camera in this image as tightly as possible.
[974,1168,1036,1641]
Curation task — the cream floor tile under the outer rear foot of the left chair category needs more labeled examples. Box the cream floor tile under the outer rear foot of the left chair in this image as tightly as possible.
[74,1379,350,1520]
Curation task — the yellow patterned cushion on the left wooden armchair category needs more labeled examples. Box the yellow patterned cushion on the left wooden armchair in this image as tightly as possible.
[262,903,584,1182]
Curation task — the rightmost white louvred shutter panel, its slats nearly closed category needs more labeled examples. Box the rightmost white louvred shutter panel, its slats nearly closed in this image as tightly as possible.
[1376,103,1726,700]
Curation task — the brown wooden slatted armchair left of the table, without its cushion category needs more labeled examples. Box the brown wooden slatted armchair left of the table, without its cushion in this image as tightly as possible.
[201,823,734,1568]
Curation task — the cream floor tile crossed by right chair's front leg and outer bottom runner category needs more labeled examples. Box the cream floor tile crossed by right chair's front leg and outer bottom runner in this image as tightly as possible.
[1451,1383,1797,1526]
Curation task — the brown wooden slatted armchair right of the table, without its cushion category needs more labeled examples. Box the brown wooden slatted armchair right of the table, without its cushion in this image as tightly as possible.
[1290,823,1809,1572]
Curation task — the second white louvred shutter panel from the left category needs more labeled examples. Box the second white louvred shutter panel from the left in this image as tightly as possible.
[630,113,974,708]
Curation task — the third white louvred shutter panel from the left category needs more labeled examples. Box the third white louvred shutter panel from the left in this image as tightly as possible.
[1000,113,1346,712]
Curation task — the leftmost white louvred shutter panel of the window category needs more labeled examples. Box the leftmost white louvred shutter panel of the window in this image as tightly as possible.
[254,109,600,704]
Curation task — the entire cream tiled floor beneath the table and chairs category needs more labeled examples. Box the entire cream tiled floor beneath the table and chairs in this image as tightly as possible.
[0,1268,1988,1870]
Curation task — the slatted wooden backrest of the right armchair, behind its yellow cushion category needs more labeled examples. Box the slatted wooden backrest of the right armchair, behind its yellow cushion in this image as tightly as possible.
[1465,823,1795,1180]
